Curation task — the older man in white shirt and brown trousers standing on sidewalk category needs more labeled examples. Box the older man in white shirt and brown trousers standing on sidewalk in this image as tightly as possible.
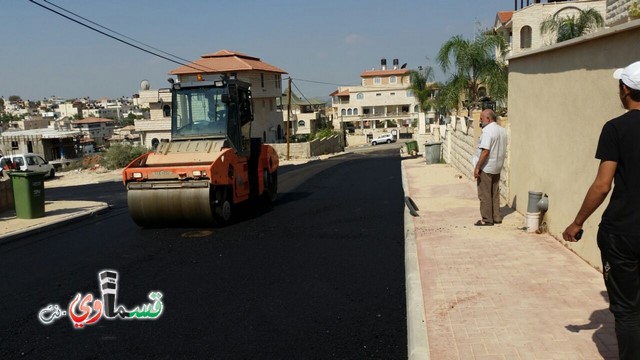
[473,109,507,226]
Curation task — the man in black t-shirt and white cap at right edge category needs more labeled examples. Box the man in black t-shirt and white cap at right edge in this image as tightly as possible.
[562,61,640,360]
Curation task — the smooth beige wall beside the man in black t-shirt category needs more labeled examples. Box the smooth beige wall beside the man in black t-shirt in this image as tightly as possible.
[509,23,640,269]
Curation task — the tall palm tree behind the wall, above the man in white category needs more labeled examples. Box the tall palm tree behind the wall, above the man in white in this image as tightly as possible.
[437,31,508,114]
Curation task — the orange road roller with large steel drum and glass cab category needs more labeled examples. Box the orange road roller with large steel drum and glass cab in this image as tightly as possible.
[122,78,278,228]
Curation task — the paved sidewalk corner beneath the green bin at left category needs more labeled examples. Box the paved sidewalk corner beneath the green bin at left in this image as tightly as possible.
[0,201,109,244]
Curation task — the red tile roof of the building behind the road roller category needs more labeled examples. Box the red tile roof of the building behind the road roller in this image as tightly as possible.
[169,50,287,75]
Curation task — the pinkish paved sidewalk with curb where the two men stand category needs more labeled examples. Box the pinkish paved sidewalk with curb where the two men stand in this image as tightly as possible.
[402,158,617,360]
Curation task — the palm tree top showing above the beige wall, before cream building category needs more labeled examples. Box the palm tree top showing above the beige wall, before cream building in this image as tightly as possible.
[540,7,604,42]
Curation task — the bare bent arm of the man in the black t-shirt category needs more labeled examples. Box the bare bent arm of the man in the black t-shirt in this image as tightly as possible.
[562,160,618,242]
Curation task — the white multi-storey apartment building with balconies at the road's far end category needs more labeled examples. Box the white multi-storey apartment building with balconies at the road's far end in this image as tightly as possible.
[330,59,424,140]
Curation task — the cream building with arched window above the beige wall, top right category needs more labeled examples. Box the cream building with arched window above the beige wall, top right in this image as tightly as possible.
[494,0,607,58]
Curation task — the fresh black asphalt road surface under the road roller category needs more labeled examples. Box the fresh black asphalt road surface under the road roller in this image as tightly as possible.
[0,147,407,359]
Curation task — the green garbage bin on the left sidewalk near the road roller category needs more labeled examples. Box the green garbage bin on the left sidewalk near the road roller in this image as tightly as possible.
[9,171,44,219]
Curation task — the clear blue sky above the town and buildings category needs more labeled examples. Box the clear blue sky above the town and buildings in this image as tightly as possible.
[0,0,514,100]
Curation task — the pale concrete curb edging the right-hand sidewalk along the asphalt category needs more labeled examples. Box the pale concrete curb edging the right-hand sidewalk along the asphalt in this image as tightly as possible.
[400,162,430,360]
